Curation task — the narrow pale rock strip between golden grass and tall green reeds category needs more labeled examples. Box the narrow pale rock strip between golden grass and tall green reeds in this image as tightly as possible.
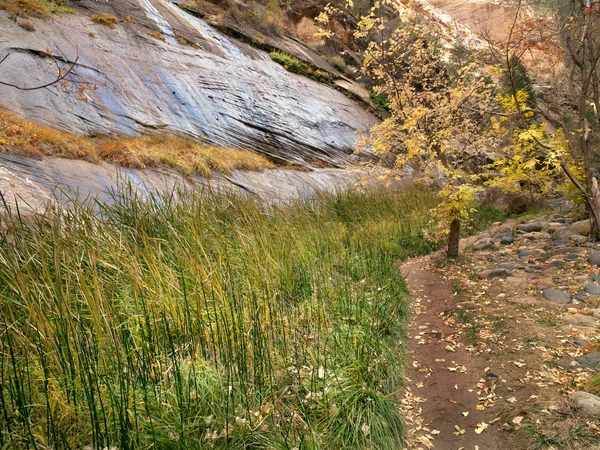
[0,154,376,211]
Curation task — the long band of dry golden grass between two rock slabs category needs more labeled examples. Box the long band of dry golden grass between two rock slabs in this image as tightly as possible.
[0,111,274,177]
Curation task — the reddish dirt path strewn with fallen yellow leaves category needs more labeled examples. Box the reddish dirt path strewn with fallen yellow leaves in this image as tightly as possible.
[401,258,506,450]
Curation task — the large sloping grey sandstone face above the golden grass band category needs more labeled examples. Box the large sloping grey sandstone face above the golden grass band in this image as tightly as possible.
[0,0,377,165]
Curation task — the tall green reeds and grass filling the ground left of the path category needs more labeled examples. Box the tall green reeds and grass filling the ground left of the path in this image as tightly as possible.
[0,185,436,450]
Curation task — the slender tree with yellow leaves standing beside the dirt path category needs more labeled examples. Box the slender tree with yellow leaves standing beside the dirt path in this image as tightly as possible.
[317,0,493,257]
